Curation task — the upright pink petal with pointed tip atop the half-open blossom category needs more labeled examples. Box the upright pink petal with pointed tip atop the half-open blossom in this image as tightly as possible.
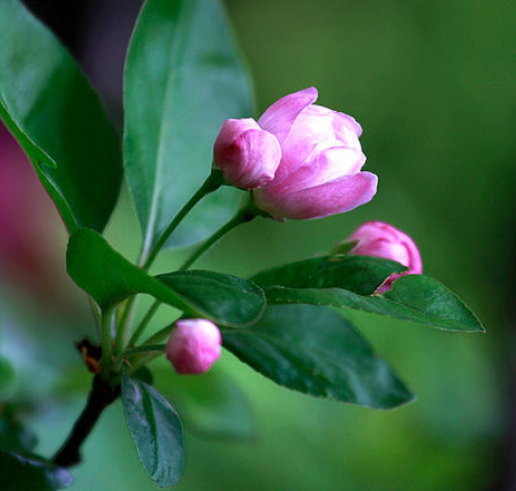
[258,87,318,144]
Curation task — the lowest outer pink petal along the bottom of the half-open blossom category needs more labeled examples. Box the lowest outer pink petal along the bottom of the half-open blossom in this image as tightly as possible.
[264,172,378,220]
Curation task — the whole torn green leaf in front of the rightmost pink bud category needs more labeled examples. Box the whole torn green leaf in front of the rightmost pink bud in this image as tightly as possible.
[252,256,484,332]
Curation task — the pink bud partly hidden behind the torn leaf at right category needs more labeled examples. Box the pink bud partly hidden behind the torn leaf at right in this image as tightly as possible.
[347,222,423,293]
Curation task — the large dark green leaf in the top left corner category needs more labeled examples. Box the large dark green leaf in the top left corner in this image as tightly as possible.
[0,0,122,232]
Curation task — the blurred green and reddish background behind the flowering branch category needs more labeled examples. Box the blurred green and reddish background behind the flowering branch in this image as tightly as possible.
[0,0,516,491]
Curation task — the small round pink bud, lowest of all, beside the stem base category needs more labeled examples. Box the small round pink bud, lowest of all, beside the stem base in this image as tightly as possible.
[165,319,222,374]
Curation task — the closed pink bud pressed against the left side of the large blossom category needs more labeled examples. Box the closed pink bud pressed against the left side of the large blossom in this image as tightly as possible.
[213,118,281,189]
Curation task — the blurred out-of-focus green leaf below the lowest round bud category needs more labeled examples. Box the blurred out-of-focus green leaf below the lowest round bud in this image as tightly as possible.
[152,361,255,440]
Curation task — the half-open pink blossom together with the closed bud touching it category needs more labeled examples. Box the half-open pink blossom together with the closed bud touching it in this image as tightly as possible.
[214,87,377,219]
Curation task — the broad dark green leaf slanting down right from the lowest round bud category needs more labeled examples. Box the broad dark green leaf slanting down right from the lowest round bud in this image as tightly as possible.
[222,305,413,409]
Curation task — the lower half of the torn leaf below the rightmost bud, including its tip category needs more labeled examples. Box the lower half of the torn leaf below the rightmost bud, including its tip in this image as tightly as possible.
[265,275,485,332]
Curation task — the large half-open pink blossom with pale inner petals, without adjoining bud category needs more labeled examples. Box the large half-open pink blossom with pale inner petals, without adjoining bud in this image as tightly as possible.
[254,87,377,219]
